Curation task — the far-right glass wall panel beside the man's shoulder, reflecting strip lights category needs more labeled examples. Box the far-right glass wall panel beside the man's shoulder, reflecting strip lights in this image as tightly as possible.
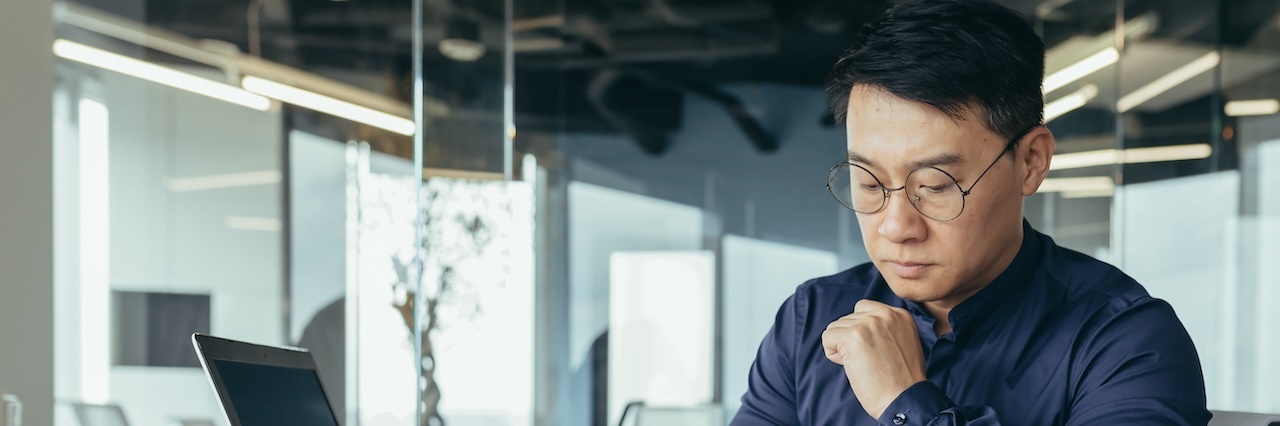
[1112,0,1280,412]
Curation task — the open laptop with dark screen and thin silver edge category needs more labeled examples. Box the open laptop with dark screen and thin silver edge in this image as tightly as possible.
[191,333,342,426]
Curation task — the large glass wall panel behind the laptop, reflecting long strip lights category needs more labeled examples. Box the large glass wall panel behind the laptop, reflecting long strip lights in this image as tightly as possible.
[51,0,421,425]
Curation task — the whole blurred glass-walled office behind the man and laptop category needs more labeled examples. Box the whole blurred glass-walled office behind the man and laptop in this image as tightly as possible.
[0,0,1280,426]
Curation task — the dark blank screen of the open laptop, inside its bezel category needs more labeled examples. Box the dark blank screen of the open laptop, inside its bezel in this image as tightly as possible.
[212,359,338,426]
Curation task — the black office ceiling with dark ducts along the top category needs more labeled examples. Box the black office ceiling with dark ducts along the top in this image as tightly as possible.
[64,0,1280,153]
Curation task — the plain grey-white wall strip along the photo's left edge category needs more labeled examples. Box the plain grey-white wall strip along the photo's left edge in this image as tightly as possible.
[0,0,54,425]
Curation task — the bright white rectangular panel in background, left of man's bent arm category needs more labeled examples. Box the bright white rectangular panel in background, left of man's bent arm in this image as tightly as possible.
[608,251,716,425]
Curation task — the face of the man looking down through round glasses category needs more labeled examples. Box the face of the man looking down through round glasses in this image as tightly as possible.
[846,86,1025,308]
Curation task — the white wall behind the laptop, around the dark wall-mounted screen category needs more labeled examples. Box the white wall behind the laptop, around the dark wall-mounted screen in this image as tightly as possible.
[49,63,285,425]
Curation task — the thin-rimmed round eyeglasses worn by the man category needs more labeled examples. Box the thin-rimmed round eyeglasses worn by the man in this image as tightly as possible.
[827,124,1039,221]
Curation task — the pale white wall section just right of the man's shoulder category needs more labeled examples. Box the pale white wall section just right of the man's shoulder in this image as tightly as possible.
[1116,170,1251,411]
